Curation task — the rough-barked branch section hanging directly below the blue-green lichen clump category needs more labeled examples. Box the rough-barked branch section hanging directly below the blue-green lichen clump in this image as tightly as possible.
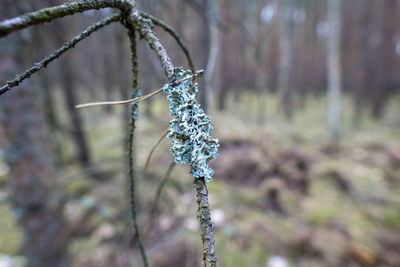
[194,178,217,267]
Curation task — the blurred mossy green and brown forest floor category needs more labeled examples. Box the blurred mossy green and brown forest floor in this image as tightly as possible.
[0,94,400,267]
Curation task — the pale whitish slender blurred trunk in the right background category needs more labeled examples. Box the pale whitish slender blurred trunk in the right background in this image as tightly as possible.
[327,0,342,139]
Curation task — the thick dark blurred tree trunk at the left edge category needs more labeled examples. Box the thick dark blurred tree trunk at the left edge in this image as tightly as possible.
[0,52,69,267]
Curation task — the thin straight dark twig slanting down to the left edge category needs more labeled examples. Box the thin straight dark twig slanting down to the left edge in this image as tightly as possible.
[0,14,121,95]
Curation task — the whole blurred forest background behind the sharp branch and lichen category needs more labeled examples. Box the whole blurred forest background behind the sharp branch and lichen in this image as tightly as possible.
[0,0,400,267]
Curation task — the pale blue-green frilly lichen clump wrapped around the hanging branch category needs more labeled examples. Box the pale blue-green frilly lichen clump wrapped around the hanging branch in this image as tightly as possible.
[163,69,219,182]
